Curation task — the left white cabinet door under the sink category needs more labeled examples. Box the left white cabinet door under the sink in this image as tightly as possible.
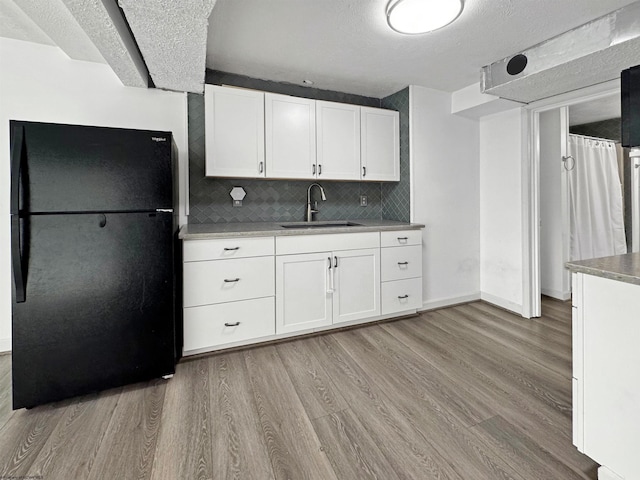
[276,252,333,334]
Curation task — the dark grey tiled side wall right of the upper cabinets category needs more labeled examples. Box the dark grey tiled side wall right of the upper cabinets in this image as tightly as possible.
[381,87,411,222]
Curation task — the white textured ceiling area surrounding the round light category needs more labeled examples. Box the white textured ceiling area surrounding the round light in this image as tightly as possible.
[206,0,640,98]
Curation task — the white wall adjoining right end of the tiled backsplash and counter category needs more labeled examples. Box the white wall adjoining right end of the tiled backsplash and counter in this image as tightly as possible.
[409,86,480,309]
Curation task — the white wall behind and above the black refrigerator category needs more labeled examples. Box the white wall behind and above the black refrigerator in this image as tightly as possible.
[0,38,188,351]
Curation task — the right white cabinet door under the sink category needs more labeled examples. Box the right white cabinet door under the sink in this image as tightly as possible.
[332,248,380,323]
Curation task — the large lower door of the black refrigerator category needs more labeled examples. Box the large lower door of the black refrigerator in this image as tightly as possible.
[12,213,175,409]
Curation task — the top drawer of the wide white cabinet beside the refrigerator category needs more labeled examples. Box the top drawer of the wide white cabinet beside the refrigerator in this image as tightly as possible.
[183,237,275,262]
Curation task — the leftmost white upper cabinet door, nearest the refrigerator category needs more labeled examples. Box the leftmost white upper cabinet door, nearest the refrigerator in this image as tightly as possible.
[204,85,265,178]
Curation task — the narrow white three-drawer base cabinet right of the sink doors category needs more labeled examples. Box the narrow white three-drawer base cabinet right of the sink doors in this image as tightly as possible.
[380,230,422,315]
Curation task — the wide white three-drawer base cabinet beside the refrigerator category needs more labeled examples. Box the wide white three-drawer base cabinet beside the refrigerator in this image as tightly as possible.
[183,237,275,356]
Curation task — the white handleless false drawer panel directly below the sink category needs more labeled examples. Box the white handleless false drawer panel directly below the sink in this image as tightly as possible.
[276,232,380,255]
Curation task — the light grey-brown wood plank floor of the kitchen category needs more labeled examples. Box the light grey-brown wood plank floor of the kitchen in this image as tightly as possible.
[0,298,597,480]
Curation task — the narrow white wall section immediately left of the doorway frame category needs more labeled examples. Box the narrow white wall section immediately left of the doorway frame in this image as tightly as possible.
[480,108,526,313]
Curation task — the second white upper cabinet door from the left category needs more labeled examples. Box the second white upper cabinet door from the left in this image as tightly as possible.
[265,93,316,179]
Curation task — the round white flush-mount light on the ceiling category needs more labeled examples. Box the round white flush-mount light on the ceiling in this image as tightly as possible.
[387,0,462,35]
